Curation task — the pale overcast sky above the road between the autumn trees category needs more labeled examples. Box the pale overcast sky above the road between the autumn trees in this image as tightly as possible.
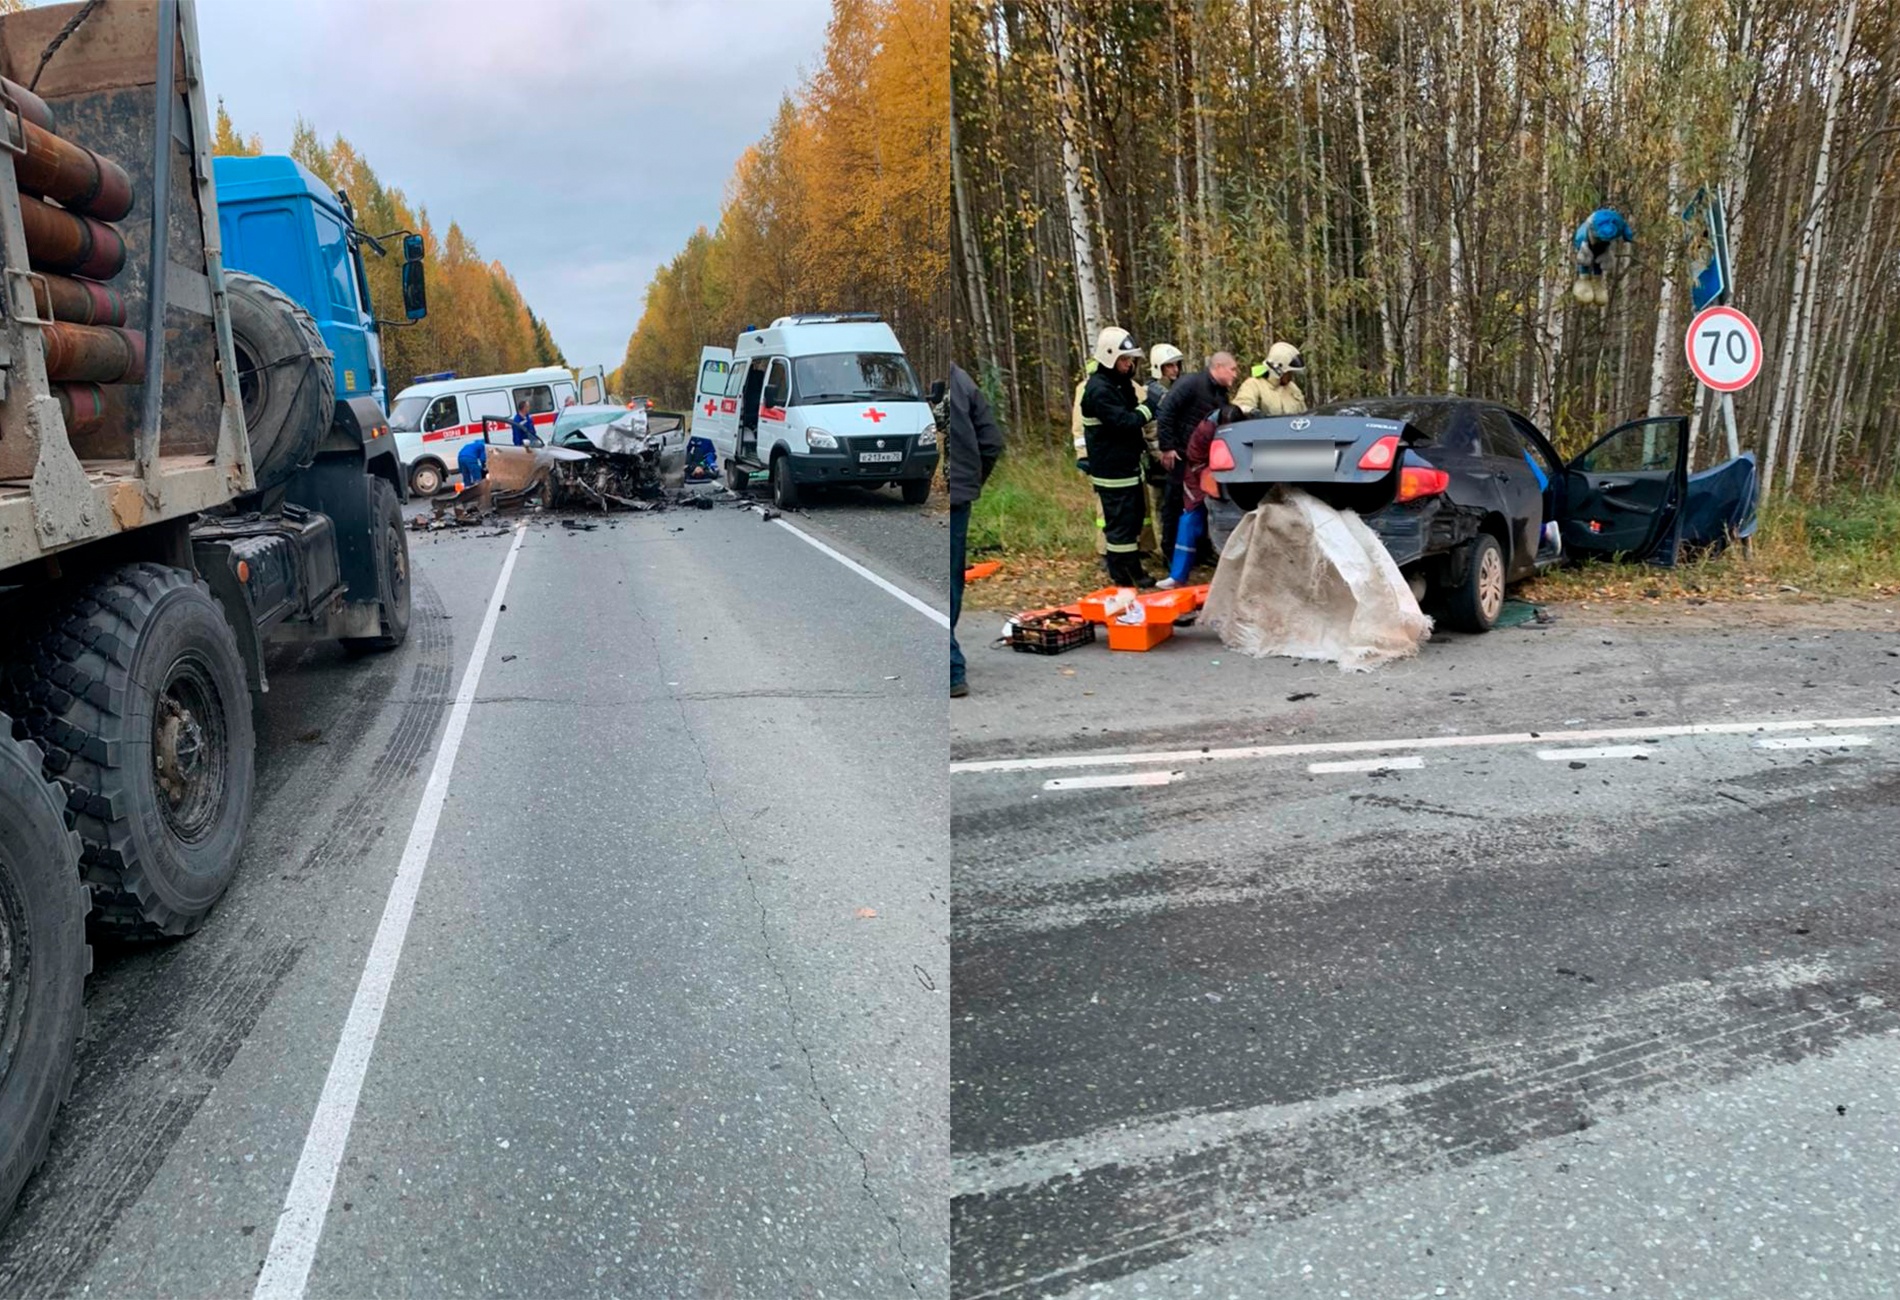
[198,0,830,368]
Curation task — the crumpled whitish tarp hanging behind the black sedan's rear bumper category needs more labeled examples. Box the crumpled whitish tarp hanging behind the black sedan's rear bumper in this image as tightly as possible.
[1205,488,1431,673]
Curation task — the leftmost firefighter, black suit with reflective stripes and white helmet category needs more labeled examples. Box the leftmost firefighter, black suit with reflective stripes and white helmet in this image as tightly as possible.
[1081,325,1155,587]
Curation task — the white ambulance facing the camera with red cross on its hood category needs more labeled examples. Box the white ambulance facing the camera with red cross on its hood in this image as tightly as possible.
[692,312,937,509]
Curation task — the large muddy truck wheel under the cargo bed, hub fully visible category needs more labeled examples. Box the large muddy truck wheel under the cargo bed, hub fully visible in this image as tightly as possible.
[4,564,257,939]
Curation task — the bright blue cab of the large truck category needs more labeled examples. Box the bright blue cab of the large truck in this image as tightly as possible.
[211,154,422,411]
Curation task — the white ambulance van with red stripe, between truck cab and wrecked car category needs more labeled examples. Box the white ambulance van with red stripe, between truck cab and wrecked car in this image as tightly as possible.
[390,365,580,496]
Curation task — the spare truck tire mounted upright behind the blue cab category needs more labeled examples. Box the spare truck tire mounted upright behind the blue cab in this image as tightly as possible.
[224,270,336,490]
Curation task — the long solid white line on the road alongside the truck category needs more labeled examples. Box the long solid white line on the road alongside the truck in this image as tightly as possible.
[253,519,528,1300]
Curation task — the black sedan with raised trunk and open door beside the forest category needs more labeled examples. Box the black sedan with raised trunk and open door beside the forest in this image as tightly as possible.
[1208,397,1689,631]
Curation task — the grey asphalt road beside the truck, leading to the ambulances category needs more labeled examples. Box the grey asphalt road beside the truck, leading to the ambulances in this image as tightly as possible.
[0,500,948,1300]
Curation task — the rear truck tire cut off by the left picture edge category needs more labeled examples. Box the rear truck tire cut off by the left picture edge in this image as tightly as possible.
[0,713,93,1224]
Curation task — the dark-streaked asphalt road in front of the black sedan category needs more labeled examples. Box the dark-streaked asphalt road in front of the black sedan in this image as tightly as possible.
[952,610,1900,1300]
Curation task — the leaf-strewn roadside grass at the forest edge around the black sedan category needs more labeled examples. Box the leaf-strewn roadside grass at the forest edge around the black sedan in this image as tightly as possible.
[963,443,1900,610]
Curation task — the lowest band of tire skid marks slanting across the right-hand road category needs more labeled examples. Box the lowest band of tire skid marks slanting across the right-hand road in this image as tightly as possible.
[952,964,1900,1300]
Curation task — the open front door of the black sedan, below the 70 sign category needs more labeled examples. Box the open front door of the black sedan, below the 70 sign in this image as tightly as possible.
[1558,416,1689,559]
